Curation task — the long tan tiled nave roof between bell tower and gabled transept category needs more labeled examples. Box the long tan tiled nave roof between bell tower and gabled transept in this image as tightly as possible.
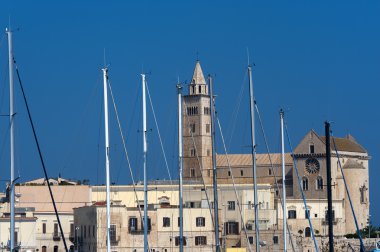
[216,153,293,167]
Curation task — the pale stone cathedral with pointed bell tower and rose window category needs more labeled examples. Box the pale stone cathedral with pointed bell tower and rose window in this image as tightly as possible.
[182,61,371,240]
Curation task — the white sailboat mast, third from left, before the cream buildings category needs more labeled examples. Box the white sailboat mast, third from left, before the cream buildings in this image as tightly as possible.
[141,74,148,252]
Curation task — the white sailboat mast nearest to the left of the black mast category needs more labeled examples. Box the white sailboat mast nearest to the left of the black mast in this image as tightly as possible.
[280,109,287,252]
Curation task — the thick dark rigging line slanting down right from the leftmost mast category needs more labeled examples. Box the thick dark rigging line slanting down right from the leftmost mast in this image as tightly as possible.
[13,58,69,252]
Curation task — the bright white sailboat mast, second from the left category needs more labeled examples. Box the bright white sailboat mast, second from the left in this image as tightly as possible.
[102,68,111,252]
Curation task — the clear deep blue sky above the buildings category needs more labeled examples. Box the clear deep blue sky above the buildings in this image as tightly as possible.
[0,0,380,225]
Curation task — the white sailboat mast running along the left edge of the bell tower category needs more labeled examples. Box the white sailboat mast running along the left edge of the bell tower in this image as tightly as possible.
[177,83,184,252]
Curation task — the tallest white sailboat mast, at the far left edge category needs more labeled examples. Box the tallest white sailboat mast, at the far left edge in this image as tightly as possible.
[6,27,15,251]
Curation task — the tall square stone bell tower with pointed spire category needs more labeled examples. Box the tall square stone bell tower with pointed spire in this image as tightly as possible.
[182,60,212,184]
